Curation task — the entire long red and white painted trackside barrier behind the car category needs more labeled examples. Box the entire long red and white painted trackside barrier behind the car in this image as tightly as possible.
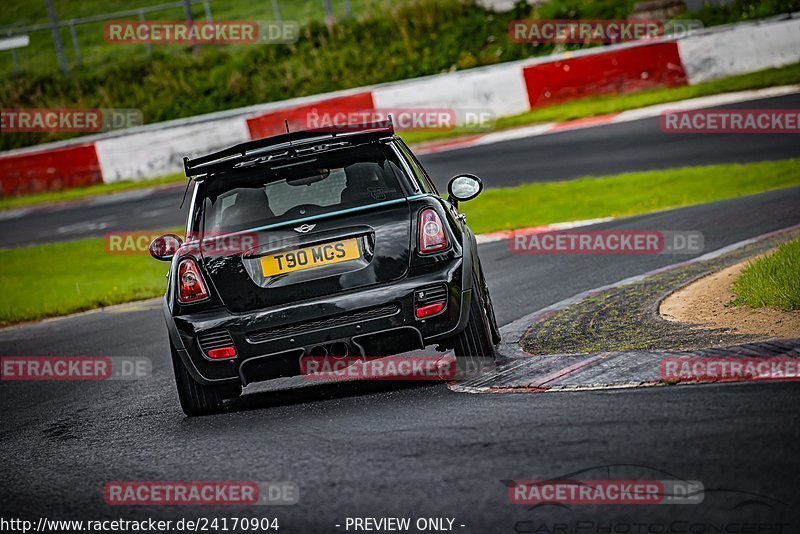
[0,18,800,196]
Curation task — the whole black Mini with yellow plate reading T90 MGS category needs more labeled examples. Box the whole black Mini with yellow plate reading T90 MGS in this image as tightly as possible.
[150,121,500,415]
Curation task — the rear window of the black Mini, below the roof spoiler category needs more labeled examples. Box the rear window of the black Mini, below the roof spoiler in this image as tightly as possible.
[198,145,410,233]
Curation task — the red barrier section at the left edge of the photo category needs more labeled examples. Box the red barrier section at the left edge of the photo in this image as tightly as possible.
[0,143,103,197]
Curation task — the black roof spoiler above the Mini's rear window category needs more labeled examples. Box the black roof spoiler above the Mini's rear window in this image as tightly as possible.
[183,116,394,178]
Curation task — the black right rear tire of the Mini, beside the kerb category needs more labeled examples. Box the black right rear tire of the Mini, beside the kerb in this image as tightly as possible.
[453,280,495,379]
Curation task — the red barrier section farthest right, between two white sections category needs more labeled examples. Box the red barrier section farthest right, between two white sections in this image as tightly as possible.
[522,42,687,108]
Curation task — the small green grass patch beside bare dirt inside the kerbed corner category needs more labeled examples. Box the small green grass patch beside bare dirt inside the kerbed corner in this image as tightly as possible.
[731,239,800,311]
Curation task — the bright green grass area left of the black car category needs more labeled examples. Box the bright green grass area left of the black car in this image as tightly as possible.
[0,238,168,325]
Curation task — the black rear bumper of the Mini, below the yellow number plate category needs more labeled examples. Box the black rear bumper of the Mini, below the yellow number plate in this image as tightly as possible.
[164,254,472,385]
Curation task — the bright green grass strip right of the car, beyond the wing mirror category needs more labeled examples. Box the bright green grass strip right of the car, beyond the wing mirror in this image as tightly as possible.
[460,159,800,233]
